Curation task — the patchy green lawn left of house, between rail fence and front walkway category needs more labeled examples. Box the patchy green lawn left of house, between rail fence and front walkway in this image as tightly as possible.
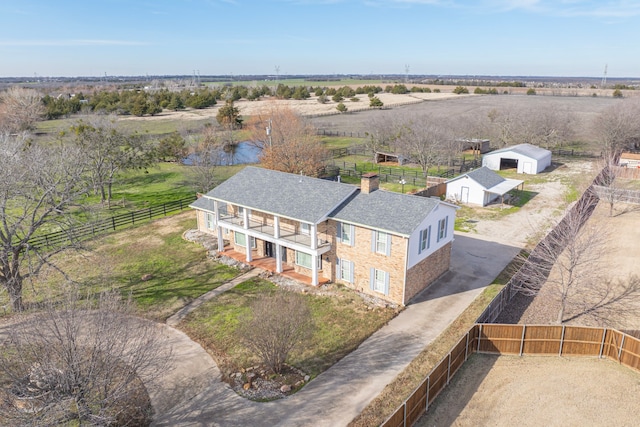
[17,211,240,320]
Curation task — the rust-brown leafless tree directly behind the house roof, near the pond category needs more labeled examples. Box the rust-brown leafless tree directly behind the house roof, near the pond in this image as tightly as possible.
[248,103,327,176]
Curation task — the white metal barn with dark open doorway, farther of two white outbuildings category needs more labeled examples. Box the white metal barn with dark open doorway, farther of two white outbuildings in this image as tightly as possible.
[482,144,551,174]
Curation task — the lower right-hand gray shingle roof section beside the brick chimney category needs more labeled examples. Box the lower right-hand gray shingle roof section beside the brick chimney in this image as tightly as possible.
[331,190,440,236]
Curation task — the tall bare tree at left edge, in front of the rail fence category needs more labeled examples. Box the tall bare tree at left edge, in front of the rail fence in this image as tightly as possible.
[0,134,88,311]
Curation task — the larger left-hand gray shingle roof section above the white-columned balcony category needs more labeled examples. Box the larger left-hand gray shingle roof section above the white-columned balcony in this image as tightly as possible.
[191,166,357,223]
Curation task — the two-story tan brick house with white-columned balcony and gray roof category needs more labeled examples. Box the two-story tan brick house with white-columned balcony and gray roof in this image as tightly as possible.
[191,166,457,305]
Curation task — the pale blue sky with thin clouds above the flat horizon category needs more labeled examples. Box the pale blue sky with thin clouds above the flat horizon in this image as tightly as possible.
[0,0,640,77]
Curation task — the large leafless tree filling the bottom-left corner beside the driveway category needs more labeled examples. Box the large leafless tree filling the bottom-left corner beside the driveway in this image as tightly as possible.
[0,289,171,426]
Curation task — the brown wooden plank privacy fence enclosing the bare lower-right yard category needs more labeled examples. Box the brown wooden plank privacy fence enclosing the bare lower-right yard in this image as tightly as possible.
[382,324,640,427]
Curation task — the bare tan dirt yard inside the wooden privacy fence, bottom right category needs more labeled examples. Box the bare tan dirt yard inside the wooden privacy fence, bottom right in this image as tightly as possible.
[416,354,640,427]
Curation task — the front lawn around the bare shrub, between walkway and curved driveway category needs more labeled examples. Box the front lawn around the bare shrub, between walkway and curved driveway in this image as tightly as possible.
[181,279,396,377]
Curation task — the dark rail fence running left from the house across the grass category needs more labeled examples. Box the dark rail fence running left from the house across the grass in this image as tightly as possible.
[29,197,195,248]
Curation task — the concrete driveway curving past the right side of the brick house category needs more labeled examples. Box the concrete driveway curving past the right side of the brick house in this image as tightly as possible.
[150,233,520,426]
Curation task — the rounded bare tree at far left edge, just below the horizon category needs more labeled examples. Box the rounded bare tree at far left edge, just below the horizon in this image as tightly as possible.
[0,86,45,132]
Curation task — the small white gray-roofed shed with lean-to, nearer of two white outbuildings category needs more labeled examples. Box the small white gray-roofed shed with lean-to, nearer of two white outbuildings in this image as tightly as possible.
[446,166,523,206]
